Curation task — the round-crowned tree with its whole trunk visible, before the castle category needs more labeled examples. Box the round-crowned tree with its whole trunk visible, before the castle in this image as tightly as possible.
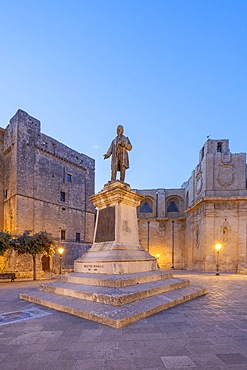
[12,230,54,280]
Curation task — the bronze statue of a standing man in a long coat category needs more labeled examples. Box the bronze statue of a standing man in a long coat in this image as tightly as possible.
[104,125,132,181]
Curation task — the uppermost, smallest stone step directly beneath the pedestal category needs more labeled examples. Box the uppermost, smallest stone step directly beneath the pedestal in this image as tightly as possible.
[58,270,173,288]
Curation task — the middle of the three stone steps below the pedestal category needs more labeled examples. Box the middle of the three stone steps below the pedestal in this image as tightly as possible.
[40,278,189,306]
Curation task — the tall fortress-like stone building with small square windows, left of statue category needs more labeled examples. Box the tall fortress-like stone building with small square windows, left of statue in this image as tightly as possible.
[0,110,95,271]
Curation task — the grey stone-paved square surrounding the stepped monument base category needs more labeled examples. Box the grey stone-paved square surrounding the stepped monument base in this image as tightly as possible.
[0,271,247,370]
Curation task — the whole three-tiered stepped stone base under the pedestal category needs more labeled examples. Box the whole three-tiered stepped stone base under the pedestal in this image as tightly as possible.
[20,270,207,328]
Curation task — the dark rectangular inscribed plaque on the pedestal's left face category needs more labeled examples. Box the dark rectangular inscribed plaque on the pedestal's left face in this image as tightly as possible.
[95,206,115,243]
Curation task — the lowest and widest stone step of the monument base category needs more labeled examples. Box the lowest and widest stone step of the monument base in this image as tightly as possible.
[20,285,207,328]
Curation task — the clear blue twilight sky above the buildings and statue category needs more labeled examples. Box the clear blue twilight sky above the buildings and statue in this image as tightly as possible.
[0,0,247,191]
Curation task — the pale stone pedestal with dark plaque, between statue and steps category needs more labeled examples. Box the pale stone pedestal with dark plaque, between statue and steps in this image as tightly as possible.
[74,181,158,274]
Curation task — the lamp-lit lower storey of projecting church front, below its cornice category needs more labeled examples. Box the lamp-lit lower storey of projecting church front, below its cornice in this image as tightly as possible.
[186,197,247,273]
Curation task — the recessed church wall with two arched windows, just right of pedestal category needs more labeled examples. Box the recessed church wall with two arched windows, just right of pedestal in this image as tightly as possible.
[137,189,186,269]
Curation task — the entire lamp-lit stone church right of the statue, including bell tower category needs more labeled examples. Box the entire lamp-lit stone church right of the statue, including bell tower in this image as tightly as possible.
[138,140,247,273]
